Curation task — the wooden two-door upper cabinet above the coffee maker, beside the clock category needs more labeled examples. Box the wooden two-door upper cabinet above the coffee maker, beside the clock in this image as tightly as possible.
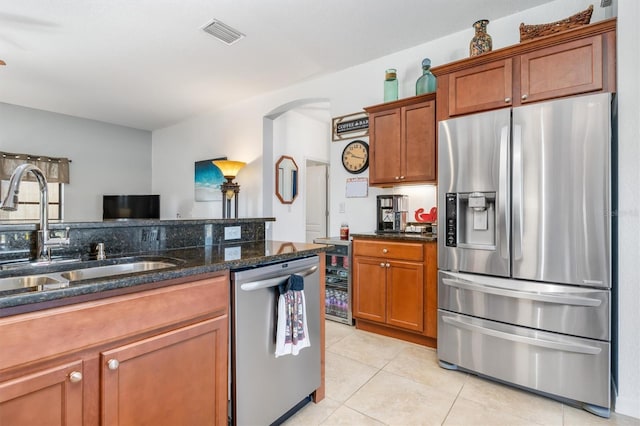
[365,93,436,186]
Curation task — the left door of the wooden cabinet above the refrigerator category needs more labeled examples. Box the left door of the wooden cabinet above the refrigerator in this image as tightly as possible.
[449,58,513,116]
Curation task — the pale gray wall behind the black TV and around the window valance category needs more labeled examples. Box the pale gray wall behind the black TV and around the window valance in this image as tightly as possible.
[0,103,151,222]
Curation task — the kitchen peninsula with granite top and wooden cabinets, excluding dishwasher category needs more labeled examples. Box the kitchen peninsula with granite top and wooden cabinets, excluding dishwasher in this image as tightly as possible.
[0,218,327,424]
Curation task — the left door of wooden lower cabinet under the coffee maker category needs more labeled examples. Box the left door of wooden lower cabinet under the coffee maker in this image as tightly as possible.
[353,256,386,323]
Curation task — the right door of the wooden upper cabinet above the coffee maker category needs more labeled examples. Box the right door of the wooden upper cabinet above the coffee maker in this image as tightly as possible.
[400,100,437,182]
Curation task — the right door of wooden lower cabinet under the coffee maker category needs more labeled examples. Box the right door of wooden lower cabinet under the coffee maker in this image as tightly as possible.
[386,261,424,332]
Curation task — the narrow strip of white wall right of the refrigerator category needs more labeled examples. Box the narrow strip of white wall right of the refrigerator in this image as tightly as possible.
[616,0,640,418]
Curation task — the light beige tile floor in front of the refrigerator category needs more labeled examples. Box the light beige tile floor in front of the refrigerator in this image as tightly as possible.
[285,321,640,426]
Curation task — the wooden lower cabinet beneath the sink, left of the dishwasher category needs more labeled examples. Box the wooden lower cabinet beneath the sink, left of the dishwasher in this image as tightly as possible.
[0,272,229,426]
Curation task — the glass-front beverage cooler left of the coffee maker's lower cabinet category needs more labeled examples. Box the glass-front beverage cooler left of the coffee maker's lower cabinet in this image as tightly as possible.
[313,238,353,325]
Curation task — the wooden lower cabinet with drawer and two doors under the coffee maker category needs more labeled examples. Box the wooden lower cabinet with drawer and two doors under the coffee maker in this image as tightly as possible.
[353,238,437,347]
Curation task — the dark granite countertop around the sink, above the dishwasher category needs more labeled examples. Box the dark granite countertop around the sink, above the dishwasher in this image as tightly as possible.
[0,241,328,317]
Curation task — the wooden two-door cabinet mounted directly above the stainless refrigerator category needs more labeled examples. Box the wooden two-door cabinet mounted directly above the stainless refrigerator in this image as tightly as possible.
[432,19,616,121]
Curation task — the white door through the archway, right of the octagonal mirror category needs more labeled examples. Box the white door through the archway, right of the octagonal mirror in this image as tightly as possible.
[305,161,328,243]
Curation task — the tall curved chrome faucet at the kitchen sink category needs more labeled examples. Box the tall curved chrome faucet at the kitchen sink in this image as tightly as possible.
[0,164,70,262]
